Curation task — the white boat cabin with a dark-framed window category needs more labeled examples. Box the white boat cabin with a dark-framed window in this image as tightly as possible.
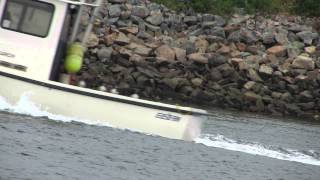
[0,0,101,80]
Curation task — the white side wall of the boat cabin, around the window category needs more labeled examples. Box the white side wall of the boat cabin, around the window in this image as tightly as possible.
[0,0,68,80]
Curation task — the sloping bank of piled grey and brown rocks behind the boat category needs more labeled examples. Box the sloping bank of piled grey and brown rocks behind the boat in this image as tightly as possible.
[74,0,320,119]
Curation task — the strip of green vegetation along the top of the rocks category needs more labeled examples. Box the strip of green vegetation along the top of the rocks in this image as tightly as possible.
[153,0,320,16]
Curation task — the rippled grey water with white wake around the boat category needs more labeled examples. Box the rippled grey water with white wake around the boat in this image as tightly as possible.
[0,97,320,180]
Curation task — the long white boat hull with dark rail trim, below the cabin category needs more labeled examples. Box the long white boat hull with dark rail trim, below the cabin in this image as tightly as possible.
[0,72,206,141]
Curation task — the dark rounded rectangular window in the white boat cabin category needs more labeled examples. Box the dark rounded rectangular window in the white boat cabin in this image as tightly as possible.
[1,0,54,37]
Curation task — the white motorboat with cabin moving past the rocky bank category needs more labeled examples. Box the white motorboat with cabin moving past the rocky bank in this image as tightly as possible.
[0,0,208,141]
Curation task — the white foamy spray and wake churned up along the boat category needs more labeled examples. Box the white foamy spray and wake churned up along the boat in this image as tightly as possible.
[0,94,320,166]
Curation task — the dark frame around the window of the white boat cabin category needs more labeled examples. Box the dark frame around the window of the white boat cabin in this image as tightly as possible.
[0,0,56,38]
